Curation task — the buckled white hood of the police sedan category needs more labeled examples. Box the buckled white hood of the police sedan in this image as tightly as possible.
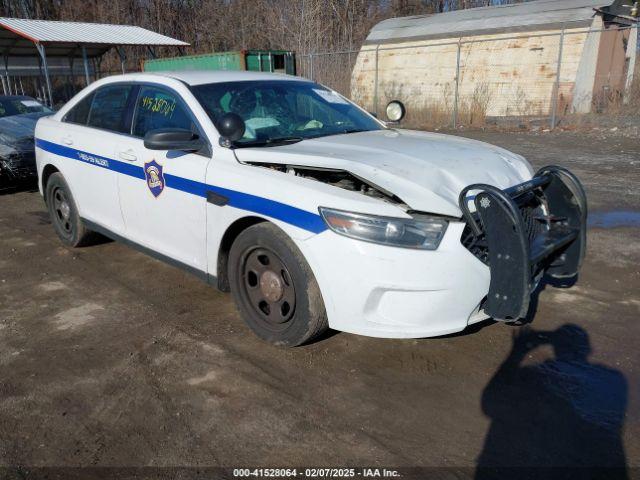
[235,130,533,217]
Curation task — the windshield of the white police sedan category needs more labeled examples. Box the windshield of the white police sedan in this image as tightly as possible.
[193,80,383,146]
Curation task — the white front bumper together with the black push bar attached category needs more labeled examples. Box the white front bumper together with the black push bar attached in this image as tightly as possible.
[298,167,587,338]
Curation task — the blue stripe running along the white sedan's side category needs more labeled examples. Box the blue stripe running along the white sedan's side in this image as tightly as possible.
[35,139,327,233]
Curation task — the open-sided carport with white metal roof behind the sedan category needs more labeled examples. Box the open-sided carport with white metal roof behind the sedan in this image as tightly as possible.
[0,18,189,105]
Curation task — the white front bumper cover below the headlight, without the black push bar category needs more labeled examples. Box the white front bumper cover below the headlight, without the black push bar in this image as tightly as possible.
[298,221,490,338]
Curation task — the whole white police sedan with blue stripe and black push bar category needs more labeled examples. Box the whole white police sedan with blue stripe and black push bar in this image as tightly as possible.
[36,72,587,346]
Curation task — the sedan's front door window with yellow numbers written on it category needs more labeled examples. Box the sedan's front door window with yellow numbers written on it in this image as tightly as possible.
[133,86,198,137]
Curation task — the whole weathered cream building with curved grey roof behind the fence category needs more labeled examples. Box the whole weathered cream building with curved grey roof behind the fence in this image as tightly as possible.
[351,0,638,123]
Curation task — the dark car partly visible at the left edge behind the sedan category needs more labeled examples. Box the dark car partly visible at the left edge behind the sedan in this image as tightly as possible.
[0,95,53,187]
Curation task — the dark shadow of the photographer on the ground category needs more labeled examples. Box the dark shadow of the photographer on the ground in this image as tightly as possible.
[476,324,628,479]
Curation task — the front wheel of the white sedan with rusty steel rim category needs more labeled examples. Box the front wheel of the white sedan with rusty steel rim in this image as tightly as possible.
[228,222,328,347]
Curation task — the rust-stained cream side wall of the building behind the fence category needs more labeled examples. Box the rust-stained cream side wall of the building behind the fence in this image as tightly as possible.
[351,25,587,116]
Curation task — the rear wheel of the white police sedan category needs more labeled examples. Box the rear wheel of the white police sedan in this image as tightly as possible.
[45,173,92,247]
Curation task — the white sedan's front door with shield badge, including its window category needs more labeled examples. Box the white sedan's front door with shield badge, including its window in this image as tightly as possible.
[116,85,210,272]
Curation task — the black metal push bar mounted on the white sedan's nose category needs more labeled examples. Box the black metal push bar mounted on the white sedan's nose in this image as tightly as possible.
[459,165,587,321]
